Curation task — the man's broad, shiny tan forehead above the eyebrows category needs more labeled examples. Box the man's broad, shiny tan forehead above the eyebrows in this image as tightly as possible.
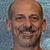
[11,1,40,14]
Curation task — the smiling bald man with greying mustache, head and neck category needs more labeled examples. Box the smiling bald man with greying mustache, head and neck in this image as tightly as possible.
[6,0,46,50]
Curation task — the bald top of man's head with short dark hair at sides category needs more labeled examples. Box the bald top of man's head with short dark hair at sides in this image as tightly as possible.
[8,0,43,19]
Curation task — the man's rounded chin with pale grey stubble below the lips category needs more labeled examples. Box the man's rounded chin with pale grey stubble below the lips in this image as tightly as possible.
[18,36,36,47]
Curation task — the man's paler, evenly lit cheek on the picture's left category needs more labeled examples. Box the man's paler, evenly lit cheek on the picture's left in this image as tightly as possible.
[12,21,25,36]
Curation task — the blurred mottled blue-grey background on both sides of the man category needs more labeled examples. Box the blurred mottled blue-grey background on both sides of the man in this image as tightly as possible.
[0,0,50,50]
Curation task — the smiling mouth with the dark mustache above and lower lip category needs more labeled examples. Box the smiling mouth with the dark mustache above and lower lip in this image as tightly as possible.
[15,28,37,39]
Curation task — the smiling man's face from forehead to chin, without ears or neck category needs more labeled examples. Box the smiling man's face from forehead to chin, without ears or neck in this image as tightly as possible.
[6,1,45,46]
